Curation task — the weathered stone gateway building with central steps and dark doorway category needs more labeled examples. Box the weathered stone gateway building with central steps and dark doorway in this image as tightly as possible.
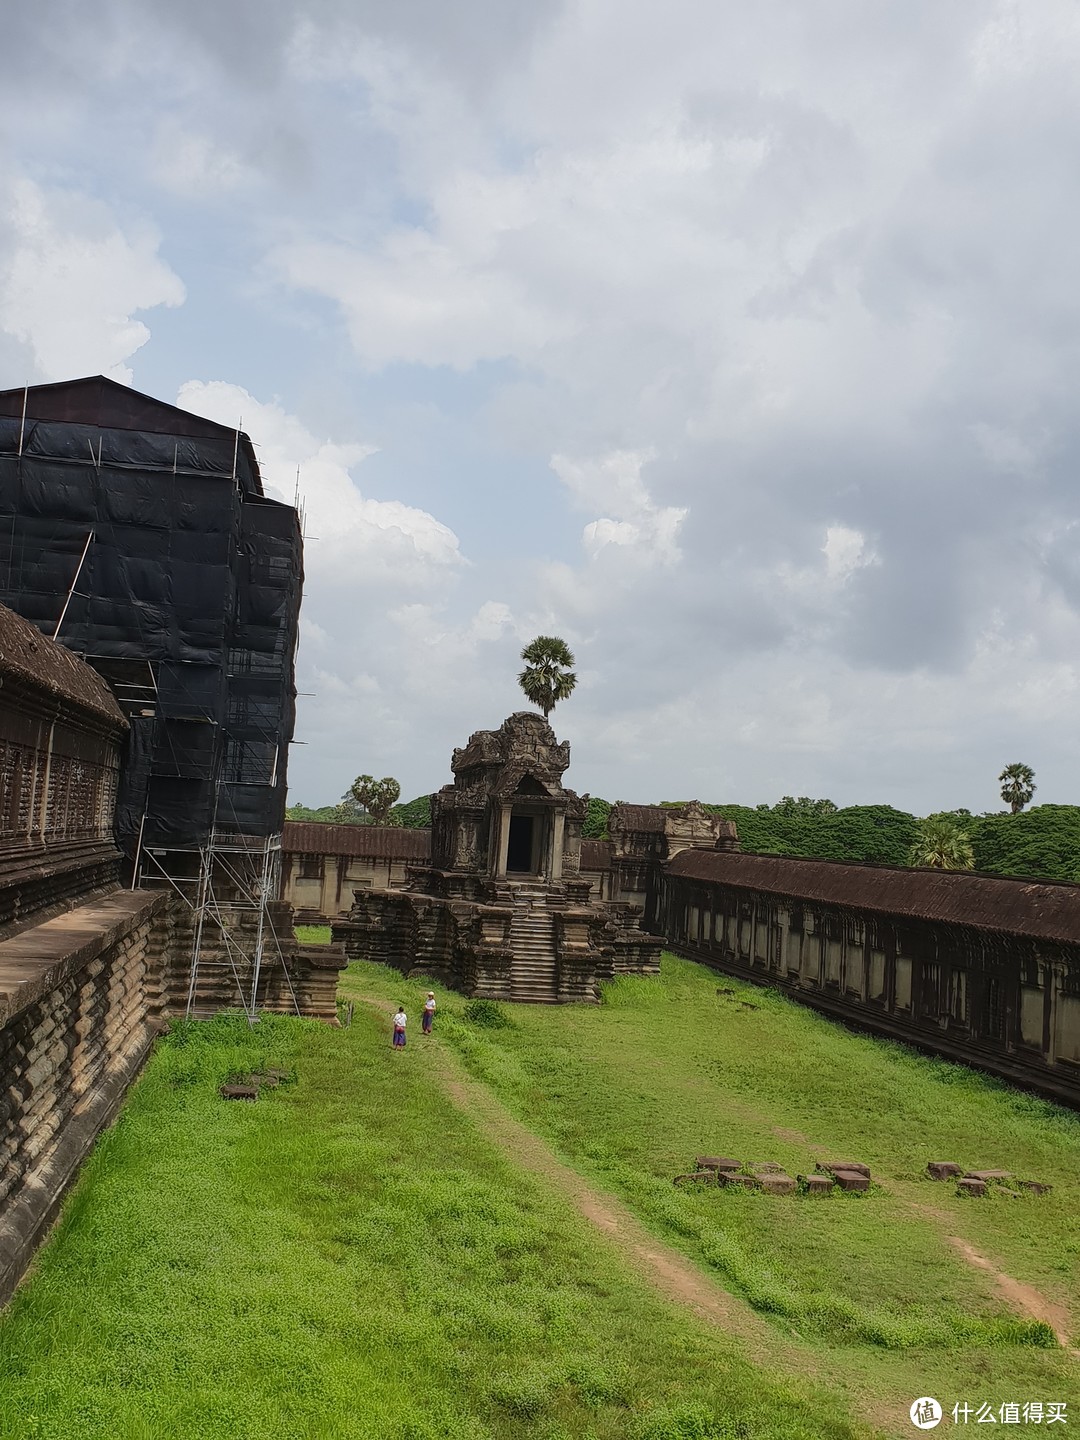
[334,711,660,1002]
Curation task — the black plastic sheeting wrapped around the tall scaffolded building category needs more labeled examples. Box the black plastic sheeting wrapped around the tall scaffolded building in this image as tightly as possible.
[0,408,302,854]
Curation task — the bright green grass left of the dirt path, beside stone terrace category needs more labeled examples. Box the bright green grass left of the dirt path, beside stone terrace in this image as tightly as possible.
[0,1002,867,1440]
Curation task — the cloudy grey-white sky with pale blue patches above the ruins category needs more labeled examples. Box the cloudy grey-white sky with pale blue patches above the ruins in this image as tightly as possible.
[0,0,1080,812]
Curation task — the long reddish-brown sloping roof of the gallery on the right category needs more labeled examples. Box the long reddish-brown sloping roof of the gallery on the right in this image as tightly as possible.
[665,850,1080,945]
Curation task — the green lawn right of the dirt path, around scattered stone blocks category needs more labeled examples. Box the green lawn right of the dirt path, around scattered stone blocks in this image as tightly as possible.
[344,956,1080,1424]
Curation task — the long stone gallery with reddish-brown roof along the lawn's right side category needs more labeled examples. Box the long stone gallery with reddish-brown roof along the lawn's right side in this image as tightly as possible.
[658,854,1080,1106]
